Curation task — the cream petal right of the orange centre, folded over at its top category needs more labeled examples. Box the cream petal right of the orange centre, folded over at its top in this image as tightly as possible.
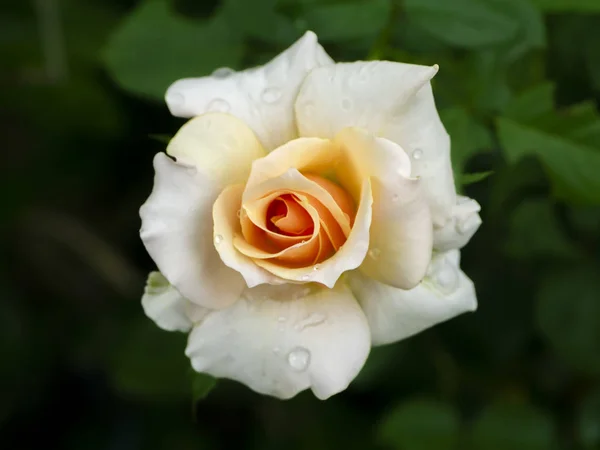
[335,128,433,289]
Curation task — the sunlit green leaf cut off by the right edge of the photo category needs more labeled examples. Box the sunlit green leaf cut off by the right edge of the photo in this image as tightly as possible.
[496,118,600,204]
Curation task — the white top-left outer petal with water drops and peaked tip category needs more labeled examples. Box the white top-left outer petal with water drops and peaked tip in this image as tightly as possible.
[166,31,333,150]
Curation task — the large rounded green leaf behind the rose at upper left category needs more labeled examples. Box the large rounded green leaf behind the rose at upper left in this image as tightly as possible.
[104,0,242,101]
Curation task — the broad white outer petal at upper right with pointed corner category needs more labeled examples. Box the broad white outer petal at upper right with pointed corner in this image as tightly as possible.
[295,61,456,226]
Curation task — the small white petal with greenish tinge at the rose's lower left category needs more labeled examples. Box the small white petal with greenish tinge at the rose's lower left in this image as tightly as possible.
[142,272,210,331]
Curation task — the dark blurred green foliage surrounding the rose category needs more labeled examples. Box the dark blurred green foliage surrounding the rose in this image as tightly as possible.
[0,0,600,450]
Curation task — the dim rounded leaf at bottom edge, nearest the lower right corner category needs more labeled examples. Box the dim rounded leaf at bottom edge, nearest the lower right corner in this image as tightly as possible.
[471,404,555,450]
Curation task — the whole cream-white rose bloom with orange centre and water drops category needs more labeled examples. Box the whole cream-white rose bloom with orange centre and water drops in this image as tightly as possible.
[140,32,481,398]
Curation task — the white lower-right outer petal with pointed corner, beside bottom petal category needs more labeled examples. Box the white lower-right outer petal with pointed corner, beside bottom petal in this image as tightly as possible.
[349,250,477,345]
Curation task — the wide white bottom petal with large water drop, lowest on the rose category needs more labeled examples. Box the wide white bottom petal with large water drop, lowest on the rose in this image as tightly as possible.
[186,283,371,399]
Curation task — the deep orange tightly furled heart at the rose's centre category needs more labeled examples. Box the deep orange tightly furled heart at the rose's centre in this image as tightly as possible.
[267,194,314,236]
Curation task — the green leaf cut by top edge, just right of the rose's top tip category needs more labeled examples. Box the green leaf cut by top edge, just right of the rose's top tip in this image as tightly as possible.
[302,0,392,42]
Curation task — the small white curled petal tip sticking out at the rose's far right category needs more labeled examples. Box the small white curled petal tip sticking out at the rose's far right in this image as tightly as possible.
[433,196,481,252]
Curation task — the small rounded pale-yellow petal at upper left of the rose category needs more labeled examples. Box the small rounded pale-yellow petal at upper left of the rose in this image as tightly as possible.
[167,113,266,186]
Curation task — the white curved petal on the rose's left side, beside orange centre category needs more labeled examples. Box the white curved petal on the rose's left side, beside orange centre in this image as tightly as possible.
[140,153,246,308]
